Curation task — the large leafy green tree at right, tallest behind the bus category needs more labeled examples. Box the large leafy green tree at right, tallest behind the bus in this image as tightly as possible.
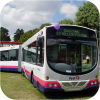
[76,2,100,37]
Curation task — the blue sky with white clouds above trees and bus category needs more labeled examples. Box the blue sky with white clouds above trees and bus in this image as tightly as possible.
[0,0,88,41]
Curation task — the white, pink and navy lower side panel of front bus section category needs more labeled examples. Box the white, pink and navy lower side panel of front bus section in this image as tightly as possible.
[21,62,46,90]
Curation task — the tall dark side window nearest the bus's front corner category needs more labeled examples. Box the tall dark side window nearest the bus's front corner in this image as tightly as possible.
[36,37,44,66]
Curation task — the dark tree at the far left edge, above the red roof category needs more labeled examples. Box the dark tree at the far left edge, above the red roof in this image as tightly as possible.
[0,27,11,41]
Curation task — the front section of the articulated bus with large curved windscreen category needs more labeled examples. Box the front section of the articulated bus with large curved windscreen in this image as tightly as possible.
[21,24,99,93]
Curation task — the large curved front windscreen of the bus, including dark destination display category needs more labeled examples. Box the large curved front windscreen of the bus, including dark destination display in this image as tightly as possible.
[47,27,97,74]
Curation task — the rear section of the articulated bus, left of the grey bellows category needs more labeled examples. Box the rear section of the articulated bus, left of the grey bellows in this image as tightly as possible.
[0,45,21,72]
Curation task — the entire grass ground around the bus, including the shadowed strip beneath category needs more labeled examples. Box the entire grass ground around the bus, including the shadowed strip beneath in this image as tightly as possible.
[0,71,100,100]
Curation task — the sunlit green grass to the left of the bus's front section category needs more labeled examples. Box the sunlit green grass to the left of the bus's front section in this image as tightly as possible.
[0,72,45,100]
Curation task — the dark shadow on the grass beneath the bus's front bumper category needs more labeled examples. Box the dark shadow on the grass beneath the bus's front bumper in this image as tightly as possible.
[45,91,98,99]
